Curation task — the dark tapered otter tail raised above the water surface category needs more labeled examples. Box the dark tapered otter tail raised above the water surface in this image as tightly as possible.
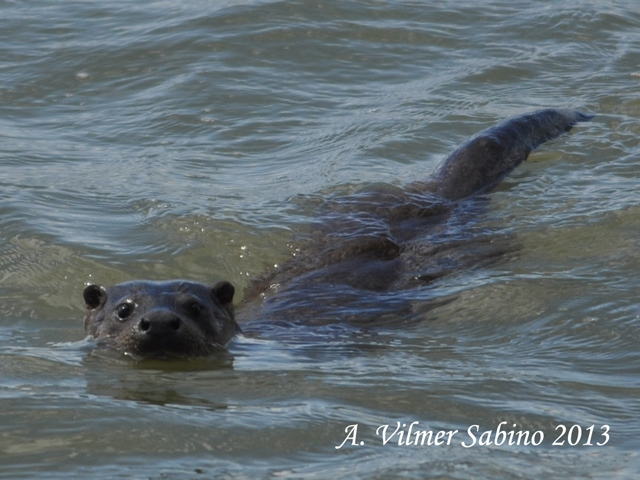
[429,109,593,201]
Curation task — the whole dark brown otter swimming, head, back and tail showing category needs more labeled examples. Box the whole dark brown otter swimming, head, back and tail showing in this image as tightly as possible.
[84,109,593,357]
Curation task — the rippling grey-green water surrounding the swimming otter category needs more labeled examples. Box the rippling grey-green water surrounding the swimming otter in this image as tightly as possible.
[0,0,640,479]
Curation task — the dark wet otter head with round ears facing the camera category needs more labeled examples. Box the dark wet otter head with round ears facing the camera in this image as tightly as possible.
[83,280,240,357]
